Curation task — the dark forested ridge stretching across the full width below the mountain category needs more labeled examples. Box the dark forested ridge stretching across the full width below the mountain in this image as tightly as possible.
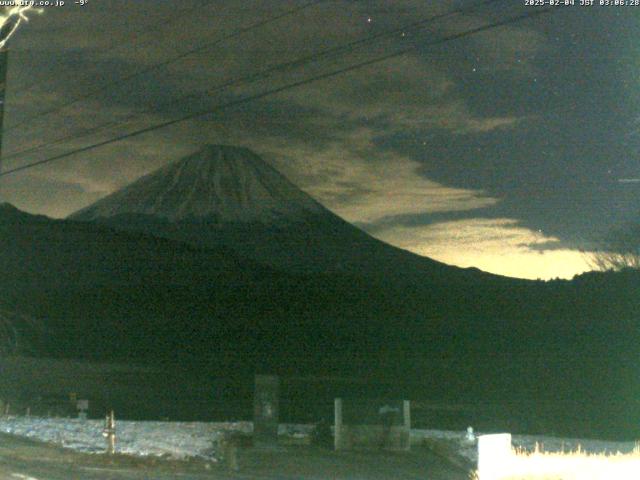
[0,205,640,433]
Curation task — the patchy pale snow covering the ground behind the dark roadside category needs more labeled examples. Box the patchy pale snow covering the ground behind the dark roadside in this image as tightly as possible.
[0,417,635,463]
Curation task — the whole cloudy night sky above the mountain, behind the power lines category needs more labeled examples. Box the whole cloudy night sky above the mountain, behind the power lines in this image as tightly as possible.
[0,0,640,278]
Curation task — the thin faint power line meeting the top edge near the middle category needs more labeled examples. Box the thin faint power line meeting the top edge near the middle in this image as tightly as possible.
[4,0,327,132]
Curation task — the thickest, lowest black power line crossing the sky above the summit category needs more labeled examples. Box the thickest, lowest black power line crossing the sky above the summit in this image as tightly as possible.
[0,7,558,177]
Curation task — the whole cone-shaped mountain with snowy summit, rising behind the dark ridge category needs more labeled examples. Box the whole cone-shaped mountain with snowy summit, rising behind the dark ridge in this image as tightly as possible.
[69,145,498,283]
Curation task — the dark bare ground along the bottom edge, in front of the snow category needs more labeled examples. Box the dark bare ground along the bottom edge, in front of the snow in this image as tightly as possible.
[0,435,469,480]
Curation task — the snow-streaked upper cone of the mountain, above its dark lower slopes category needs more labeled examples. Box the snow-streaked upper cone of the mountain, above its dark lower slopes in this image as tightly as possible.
[71,145,325,223]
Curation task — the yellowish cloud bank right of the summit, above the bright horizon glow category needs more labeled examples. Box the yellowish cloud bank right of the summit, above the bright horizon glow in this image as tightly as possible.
[252,128,497,223]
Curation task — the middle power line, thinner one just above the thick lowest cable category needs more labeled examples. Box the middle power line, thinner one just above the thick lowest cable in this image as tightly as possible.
[3,0,504,160]
